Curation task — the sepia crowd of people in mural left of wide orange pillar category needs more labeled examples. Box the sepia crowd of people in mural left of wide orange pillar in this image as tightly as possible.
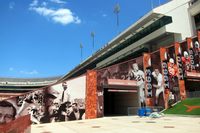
[0,82,85,124]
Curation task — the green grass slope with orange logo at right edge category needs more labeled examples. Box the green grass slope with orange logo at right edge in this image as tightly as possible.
[163,98,200,115]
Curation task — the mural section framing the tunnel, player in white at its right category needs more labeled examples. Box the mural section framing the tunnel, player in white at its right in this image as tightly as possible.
[97,57,146,116]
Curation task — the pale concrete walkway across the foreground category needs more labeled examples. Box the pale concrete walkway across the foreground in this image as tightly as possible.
[31,116,200,133]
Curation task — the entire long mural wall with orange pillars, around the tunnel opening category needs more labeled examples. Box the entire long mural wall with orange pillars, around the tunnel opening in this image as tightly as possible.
[0,32,200,124]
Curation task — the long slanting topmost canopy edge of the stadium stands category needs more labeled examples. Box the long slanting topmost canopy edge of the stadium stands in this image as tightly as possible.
[60,11,164,81]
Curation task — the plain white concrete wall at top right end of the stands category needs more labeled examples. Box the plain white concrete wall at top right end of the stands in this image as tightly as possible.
[153,0,194,40]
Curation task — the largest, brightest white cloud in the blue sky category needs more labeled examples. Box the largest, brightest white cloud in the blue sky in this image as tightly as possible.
[29,7,81,25]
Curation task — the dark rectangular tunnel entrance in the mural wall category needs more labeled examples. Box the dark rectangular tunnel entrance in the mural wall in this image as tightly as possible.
[104,88,139,116]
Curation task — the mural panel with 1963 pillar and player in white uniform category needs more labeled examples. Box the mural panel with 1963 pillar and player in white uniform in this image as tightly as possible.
[147,51,167,107]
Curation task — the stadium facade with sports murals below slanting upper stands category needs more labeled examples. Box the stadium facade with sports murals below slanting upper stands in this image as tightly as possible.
[0,0,200,129]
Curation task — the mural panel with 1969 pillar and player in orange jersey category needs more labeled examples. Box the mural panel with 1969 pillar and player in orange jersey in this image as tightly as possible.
[160,45,180,108]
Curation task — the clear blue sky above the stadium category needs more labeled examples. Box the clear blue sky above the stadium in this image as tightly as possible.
[0,0,166,78]
